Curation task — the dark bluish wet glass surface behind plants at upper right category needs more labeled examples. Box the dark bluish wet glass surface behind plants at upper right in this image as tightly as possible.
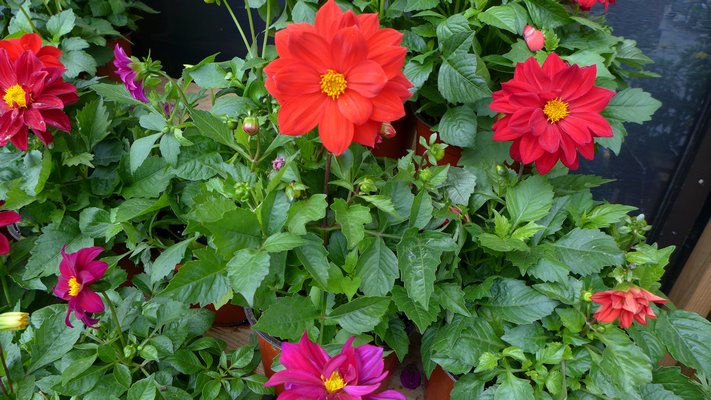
[579,0,711,221]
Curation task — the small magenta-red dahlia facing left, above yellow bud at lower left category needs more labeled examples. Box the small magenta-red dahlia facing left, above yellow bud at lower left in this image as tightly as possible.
[54,246,109,328]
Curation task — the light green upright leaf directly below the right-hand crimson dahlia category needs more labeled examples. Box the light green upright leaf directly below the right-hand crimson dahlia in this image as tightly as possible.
[506,175,553,227]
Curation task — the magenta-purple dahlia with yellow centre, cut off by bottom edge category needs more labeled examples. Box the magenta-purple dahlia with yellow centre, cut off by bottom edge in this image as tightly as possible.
[265,333,406,400]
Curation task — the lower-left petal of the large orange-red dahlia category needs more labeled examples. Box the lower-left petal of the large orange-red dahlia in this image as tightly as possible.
[278,93,333,135]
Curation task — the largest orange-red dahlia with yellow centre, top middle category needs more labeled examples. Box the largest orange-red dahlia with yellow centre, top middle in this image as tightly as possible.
[264,0,412,155]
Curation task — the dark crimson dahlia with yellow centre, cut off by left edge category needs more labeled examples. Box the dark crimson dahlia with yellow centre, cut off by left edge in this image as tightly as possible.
[0,49,79,150]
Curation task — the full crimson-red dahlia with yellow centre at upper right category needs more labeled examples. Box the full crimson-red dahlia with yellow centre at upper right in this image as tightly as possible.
[490,53,615,174]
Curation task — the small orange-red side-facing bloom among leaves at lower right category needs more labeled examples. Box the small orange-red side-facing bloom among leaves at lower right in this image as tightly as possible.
[591,286,669,329]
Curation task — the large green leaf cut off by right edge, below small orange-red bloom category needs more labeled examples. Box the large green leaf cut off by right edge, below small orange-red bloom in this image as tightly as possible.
[656,310,711,376]
